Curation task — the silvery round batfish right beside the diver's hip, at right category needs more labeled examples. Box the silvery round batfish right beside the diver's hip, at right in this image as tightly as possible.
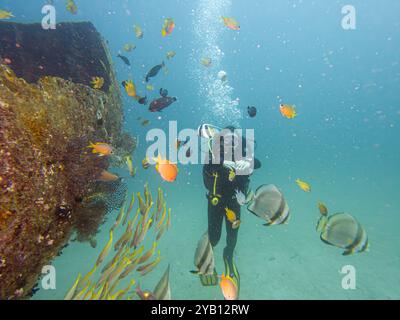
[247,184,290,226]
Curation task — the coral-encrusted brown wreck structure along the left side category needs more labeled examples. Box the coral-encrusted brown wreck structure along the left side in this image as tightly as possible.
[0,23,135,299]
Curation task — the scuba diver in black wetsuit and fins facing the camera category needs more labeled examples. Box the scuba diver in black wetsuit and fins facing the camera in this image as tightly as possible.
[199,125,261,298]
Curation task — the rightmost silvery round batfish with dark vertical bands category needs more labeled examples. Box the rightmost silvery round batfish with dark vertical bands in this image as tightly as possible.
[317,213,368,255]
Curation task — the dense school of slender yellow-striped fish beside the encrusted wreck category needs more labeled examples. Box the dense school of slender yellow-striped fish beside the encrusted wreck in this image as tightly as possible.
[64,184,171,300]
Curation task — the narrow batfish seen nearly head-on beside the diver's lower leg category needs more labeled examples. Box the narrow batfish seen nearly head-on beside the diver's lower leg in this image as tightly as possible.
[191,232,215,275]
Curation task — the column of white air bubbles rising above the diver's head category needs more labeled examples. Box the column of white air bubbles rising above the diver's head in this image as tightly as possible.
[191,0,241,126]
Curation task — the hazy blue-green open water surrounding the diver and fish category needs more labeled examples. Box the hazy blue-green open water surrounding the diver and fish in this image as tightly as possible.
[0,0,400,299]
